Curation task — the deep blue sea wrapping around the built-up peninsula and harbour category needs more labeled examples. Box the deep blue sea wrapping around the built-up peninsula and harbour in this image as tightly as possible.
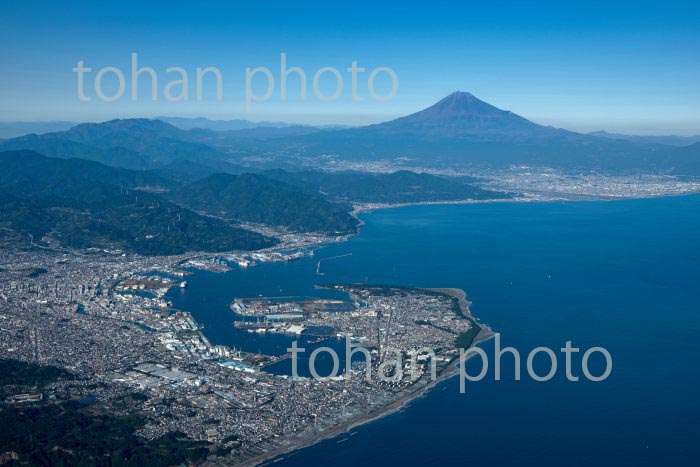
[170,196,700,467]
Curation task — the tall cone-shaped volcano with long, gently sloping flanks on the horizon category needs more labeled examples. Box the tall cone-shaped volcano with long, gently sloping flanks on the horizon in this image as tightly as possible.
[266,92,691,173]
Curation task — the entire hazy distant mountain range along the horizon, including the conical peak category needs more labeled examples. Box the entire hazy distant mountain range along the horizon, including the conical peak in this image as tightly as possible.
[0,92,700,176]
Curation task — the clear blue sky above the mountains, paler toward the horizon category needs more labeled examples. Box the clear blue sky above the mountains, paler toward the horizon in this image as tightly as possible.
[0,1,700,134]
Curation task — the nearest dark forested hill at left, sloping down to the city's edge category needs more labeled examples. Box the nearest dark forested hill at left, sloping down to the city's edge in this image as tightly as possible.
[0,151,274,255]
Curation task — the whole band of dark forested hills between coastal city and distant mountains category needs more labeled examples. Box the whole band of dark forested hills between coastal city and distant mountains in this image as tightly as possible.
[0,149,510,255]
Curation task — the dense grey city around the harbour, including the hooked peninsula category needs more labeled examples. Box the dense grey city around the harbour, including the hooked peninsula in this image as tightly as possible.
[0,245,480,462]
